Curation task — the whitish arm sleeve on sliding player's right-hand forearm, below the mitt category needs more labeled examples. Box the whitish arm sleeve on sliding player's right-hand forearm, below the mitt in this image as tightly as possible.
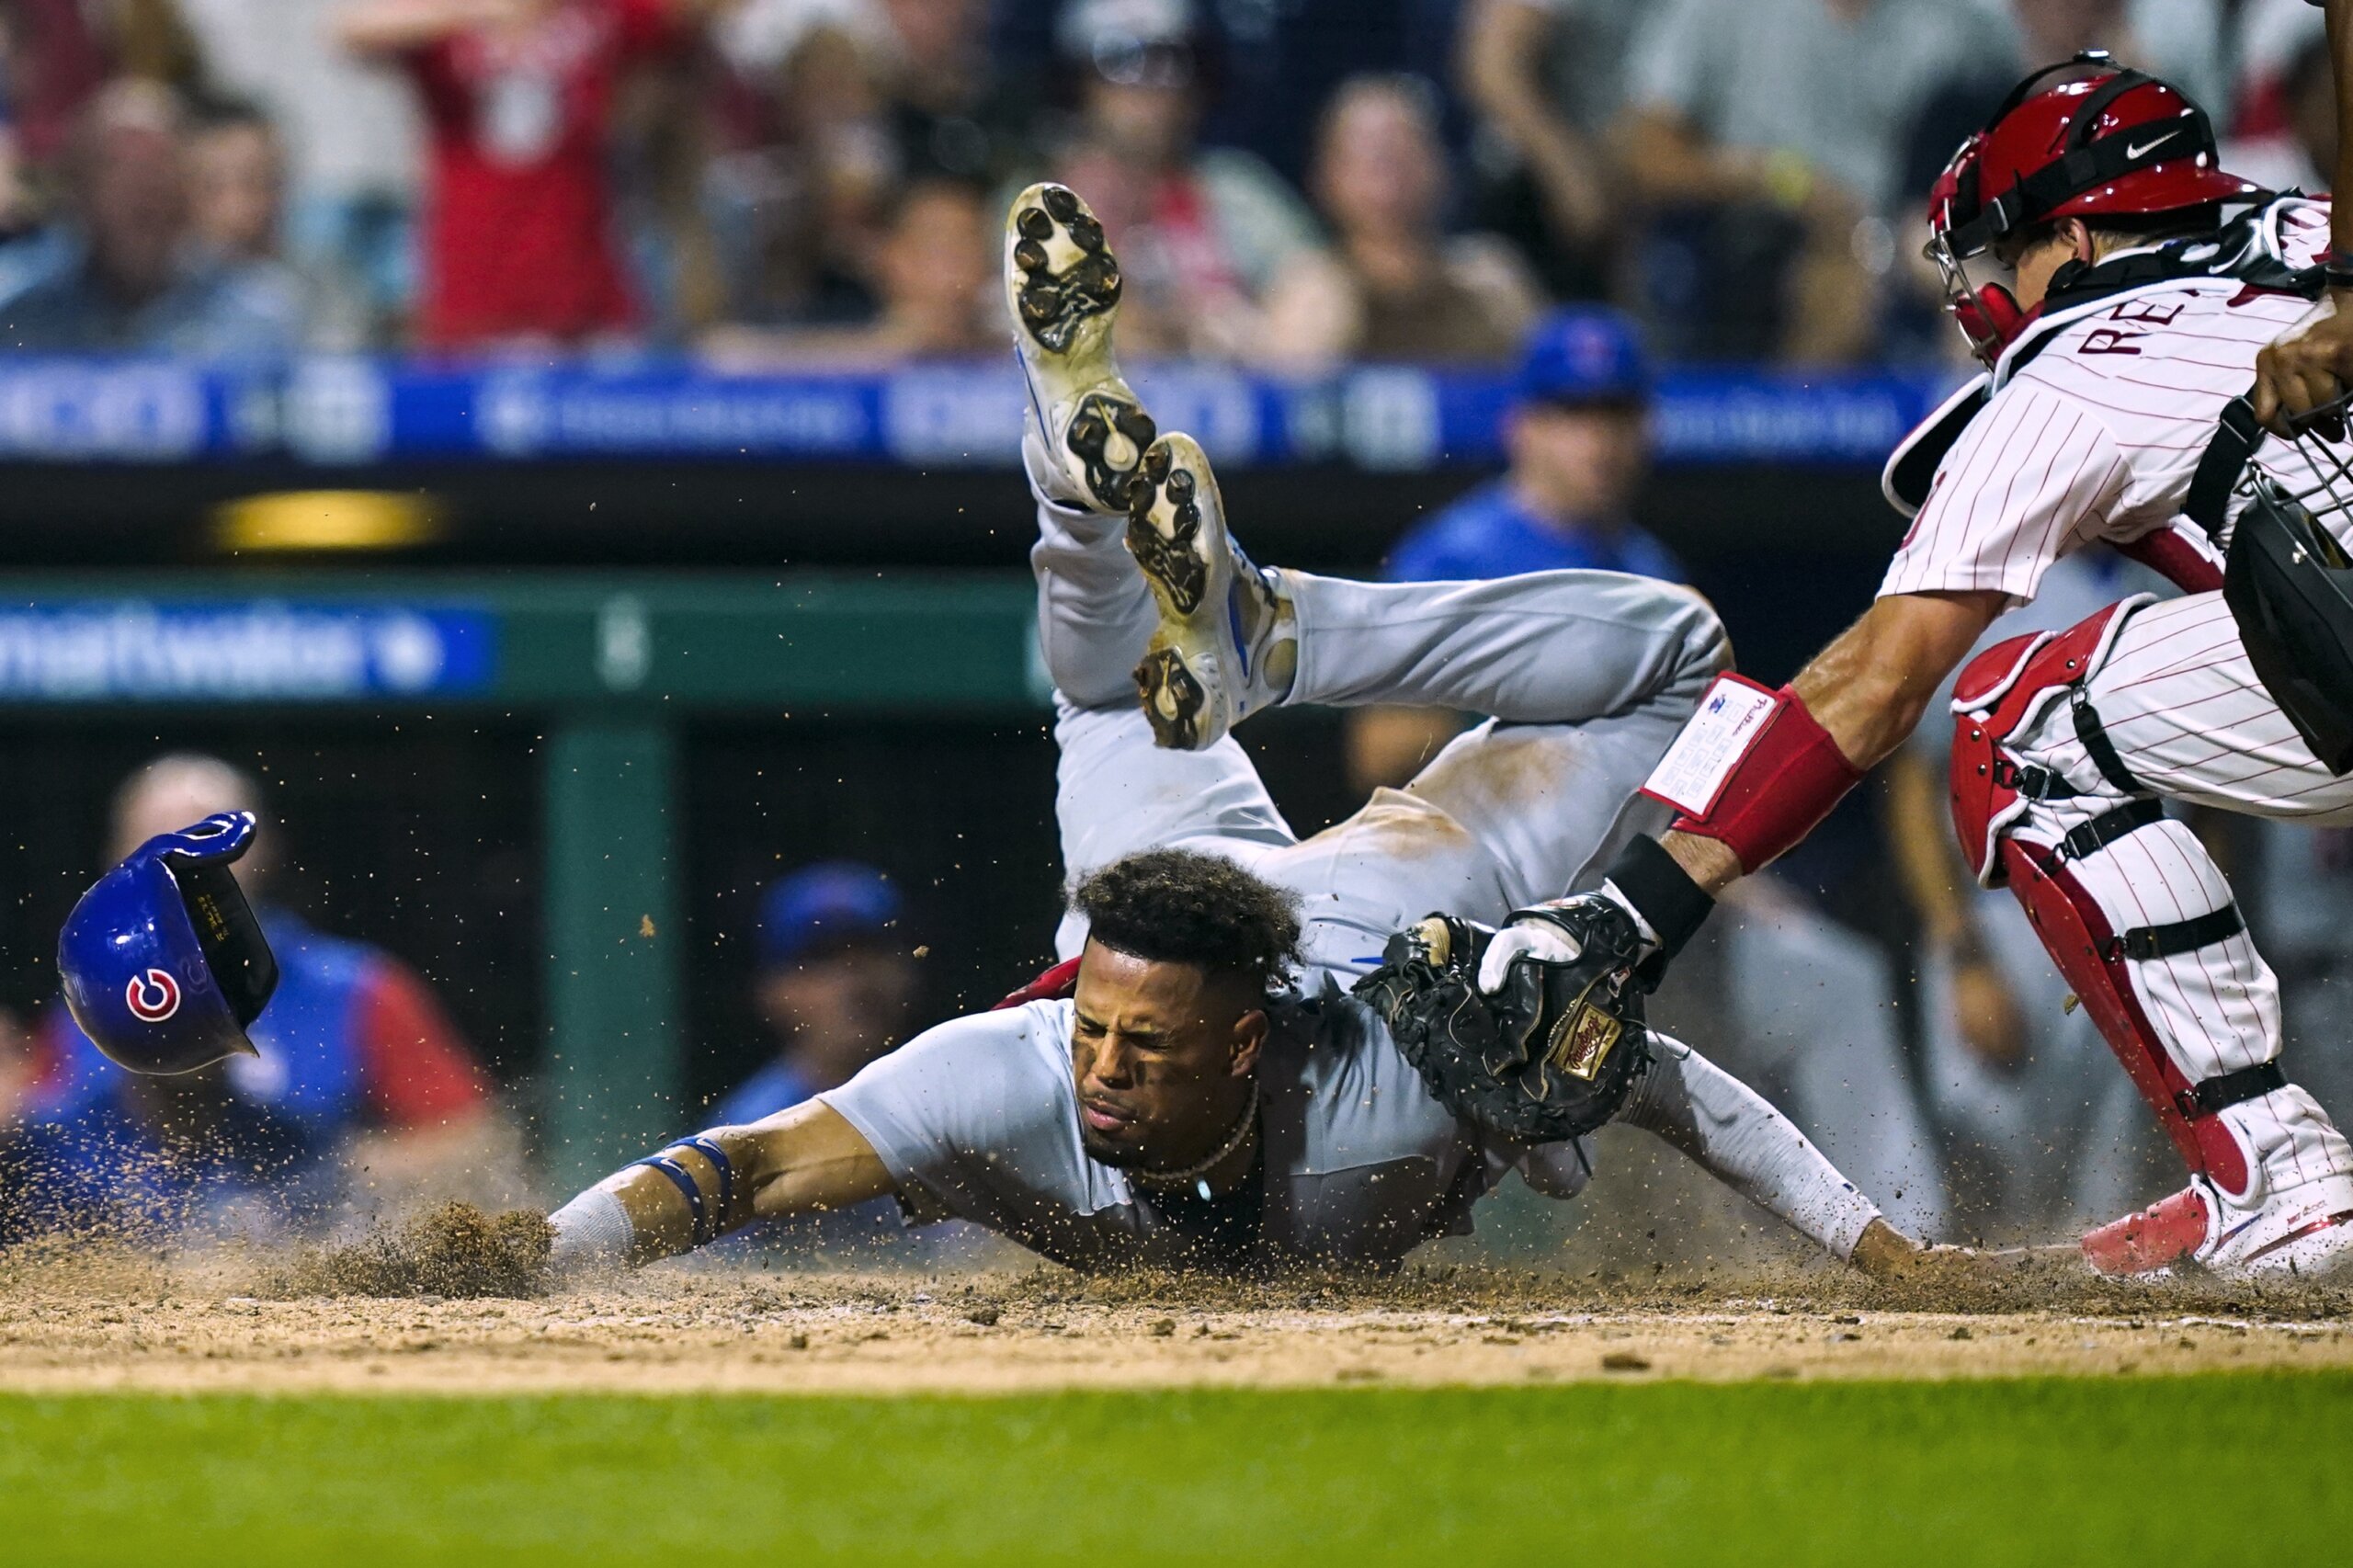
[1617,1034,1880,1257]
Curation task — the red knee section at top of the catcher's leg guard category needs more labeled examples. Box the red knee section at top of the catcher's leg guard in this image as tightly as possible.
[1953,594,2151,888]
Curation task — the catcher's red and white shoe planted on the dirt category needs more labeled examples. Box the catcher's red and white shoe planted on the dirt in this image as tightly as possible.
[2083,1175,2353,1278]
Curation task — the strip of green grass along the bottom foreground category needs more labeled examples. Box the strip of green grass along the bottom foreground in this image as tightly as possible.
[0,1375,2353,1568]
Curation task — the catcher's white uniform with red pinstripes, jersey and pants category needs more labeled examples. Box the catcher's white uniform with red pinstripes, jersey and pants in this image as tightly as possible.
[1880,202,2353,1206]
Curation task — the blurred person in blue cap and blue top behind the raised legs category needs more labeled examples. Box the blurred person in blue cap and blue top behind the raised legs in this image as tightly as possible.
[1348,306,1685,789]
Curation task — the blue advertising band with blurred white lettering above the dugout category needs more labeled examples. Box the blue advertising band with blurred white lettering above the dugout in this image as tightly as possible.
[0,353,1958,473]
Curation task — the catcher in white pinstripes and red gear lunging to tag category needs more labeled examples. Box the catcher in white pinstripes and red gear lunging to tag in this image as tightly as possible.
[1487,54,2353,1274]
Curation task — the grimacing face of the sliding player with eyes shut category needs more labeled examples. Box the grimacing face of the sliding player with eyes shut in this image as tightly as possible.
[1071,942,1266,1170]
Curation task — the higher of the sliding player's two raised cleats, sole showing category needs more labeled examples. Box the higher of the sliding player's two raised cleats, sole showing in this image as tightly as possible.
[1005,184,1160,513]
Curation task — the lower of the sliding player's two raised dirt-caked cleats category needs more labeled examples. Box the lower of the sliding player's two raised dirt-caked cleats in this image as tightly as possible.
[1127,433,1299,751]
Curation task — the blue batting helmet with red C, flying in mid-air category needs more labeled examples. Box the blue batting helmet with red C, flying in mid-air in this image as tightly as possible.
[56,812,278,1074]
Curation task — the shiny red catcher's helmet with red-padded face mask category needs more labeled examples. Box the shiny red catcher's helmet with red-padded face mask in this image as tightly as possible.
[1927,50,2261,362]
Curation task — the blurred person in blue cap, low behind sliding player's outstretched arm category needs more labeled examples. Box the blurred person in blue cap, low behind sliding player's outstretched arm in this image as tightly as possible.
[713,859,920,1123]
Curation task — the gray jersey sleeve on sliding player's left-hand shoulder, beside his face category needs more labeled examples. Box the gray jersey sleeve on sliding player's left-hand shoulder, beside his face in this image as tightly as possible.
[819,1003,1085,1229]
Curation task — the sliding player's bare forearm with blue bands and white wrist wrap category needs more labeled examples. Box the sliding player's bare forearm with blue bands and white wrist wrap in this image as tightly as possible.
[548,1099,896,1274]
